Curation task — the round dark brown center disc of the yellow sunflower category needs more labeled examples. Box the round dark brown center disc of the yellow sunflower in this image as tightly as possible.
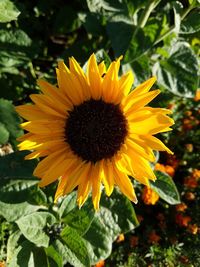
[65,99,127,163]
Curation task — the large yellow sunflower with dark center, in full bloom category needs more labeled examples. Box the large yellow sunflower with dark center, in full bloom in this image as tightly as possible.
[16,54,173,210]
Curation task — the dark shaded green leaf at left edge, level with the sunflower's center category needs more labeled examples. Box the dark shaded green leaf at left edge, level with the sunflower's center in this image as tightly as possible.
[0,99,23,147]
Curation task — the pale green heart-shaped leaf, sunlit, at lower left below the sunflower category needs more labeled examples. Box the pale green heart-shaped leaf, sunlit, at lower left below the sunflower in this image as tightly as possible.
[16,211,56,247]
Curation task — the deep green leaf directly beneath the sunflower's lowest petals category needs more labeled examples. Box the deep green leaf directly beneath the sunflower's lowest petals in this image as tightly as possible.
[62,201,94,235]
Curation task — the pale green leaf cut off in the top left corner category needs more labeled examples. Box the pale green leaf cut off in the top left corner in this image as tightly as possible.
[0,0,20,22]
